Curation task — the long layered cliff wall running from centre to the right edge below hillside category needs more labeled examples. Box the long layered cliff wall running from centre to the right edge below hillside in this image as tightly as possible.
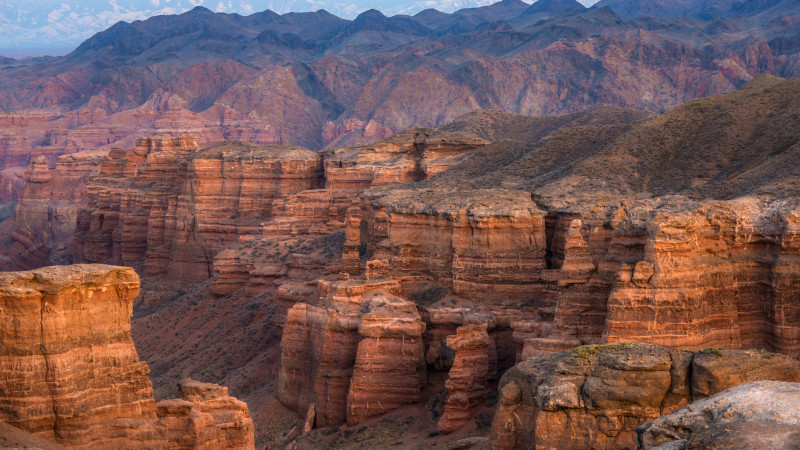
[358,195,800,356]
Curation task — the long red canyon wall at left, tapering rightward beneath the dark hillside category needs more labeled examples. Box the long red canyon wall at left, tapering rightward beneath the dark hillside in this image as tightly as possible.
[74,130,487,295]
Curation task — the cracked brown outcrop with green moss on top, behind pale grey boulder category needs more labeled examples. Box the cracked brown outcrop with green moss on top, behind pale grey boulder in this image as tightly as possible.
[492,343,800,449]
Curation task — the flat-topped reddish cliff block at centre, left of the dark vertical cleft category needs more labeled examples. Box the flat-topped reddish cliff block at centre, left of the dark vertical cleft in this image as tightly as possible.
[362,189,546,298]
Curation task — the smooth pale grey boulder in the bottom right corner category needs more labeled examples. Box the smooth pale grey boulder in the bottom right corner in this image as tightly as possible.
[637,381,800,450]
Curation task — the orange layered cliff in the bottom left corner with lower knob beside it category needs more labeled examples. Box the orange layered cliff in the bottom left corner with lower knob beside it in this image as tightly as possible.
[0,265,253,448]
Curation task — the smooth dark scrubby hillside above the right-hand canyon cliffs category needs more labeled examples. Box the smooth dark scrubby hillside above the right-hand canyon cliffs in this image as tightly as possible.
[406,75,800,208]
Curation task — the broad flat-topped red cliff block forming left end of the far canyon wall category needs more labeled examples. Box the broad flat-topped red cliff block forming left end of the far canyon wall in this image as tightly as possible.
[75,136,321,282]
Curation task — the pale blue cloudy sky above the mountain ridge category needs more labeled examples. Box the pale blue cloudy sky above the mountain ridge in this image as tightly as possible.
[0,0,597,58]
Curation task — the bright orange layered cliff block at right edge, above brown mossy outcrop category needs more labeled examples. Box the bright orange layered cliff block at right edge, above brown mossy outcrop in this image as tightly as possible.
[603,198,800,354]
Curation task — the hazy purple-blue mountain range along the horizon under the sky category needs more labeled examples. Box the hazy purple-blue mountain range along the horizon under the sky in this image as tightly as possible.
[0,0,800,152]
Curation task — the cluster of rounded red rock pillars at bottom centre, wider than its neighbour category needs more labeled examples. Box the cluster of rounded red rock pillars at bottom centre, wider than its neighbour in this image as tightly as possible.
[278,278,426,426]
